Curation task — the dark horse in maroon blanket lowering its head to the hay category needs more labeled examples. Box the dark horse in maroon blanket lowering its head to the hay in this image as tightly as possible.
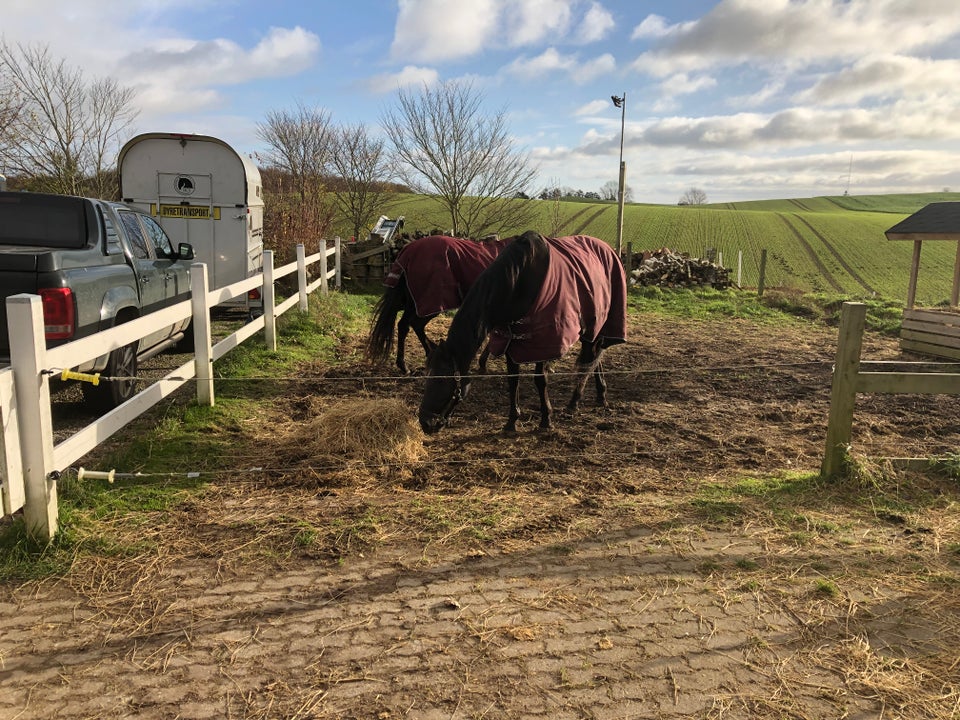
[419,231,627,433]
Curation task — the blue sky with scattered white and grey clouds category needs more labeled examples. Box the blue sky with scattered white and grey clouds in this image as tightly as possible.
[0,0,960,203]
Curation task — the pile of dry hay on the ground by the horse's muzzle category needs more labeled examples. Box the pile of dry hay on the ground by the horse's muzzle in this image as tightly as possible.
[276,398,424,468]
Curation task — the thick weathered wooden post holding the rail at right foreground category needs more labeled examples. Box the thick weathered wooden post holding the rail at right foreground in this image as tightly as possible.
[820,302,867,480]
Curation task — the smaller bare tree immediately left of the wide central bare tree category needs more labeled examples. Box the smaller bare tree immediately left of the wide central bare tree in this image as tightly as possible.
[330,124,393,240]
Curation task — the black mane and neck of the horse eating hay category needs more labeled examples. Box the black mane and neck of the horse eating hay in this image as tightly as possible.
[447,230,550,364]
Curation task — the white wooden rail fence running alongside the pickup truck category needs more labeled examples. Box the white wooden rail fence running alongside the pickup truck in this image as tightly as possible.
[0,238,341,541]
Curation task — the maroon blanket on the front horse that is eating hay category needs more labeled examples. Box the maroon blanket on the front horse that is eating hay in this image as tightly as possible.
[490,235,627,363]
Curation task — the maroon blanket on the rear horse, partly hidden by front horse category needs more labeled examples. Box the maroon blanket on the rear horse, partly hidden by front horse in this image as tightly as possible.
[383,235,507,317]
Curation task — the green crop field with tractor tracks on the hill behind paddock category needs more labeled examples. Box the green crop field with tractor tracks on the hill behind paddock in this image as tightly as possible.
[336,193,960,306]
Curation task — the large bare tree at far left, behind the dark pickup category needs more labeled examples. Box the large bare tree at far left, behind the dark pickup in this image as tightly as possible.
[0,43,137,197]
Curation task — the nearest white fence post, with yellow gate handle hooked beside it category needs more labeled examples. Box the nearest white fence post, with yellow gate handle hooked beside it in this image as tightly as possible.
[7,294,58,542]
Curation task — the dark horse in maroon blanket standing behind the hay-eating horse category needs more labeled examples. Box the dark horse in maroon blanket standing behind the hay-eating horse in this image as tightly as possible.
[367,235,510,374]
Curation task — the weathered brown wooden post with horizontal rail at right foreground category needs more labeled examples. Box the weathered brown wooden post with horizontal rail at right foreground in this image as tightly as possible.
[820,302,960,478]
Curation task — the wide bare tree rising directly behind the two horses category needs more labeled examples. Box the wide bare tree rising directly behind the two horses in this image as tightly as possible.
[382,81,536,237]
